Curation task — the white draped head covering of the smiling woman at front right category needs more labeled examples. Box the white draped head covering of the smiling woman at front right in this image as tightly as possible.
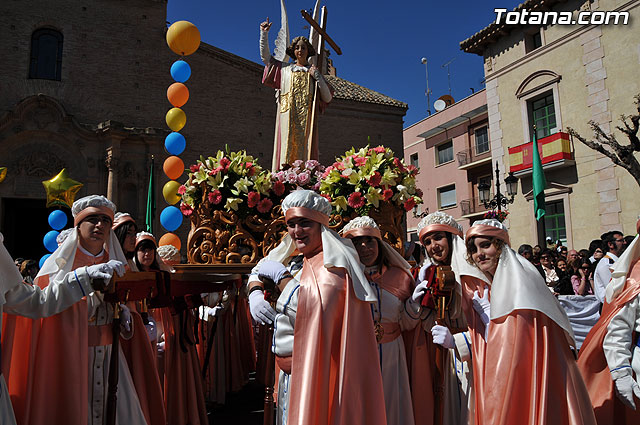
[452,219,575,347]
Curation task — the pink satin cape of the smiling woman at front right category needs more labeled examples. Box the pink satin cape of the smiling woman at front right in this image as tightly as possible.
[462,276,596,425]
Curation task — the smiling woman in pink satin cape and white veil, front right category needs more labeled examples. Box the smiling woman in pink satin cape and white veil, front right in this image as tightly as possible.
[452,220,596,425]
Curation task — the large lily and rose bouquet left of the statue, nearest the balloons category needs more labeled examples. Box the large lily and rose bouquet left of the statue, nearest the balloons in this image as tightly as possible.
[178,147,277,217]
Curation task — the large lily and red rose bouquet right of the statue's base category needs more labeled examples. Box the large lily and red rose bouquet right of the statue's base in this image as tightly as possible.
[319,146,422,215]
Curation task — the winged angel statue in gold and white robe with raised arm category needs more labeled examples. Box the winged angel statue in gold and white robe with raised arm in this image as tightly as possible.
[260,0,333,171]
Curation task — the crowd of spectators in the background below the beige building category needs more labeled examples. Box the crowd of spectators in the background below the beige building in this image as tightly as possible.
[518,231,634,296]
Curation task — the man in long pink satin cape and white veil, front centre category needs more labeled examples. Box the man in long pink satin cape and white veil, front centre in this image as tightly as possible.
[281,190,386,425]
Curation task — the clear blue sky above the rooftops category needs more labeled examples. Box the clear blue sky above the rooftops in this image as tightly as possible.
[167,0,521,127]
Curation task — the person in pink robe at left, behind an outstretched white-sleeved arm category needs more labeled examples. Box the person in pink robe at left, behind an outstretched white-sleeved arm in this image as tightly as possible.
[2,195,153,425]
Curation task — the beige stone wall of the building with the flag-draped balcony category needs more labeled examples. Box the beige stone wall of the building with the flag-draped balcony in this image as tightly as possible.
[485,1,640,249]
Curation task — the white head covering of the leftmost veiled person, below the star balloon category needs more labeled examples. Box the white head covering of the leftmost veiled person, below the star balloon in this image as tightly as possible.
[36,195,127,283]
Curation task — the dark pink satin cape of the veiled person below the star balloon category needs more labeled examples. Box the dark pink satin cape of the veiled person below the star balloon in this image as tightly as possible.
[3,248,100,425]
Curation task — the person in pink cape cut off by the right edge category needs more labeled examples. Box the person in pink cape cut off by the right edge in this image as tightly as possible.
[578,221,640,425]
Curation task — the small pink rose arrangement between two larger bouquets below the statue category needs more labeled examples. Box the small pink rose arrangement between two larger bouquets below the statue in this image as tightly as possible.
[271,159,324,196]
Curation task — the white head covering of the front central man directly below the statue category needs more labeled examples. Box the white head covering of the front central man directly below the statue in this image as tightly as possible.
[269,190,377,302]
